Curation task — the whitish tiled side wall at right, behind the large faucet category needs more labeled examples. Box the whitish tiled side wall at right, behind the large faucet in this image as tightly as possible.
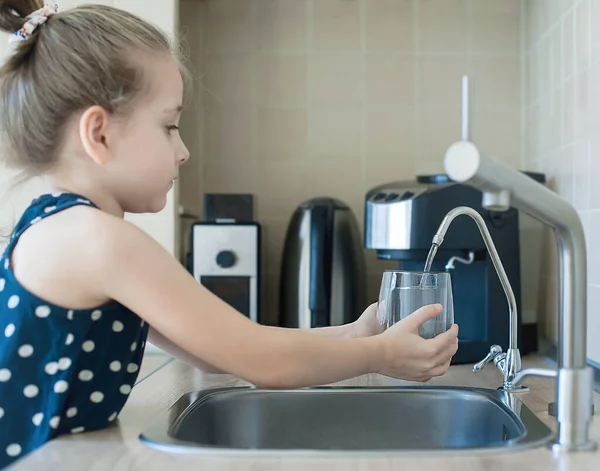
[523,0,600,362]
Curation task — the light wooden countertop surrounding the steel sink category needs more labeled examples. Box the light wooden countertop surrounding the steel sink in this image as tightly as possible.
[10,355,600,471]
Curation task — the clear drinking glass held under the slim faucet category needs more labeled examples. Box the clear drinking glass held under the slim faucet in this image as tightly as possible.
[377,270,454,339]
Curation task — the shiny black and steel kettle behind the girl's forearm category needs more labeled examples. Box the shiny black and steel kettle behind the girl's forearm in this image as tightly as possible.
[279,198,366,328]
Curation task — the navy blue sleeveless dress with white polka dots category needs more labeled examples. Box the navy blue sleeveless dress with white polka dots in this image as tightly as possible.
[0,193,148,469]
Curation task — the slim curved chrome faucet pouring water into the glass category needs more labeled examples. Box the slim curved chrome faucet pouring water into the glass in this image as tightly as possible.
[432,206,521,391]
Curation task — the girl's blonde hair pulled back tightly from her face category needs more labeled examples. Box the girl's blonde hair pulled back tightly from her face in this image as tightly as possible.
[0,0,181,176]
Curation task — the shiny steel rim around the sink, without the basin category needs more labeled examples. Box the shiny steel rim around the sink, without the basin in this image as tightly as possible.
[138,386,554,458]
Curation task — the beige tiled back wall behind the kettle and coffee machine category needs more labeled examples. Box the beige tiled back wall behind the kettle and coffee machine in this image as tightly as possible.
[192,0,522,320]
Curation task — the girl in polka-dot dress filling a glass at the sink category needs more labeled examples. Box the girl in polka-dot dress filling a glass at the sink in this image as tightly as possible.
[0,0,458,467]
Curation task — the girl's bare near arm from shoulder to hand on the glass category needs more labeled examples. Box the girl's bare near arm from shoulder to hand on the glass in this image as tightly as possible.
[12,206,458,388]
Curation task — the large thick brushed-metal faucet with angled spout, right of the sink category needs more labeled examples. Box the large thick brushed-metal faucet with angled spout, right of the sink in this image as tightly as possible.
[444,139,596,451]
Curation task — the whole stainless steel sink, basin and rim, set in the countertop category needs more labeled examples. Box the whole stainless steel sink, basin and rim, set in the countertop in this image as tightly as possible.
[140,387,553,453]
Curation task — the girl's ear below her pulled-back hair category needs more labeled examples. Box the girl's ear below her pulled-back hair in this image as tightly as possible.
[79,105,113,165]
